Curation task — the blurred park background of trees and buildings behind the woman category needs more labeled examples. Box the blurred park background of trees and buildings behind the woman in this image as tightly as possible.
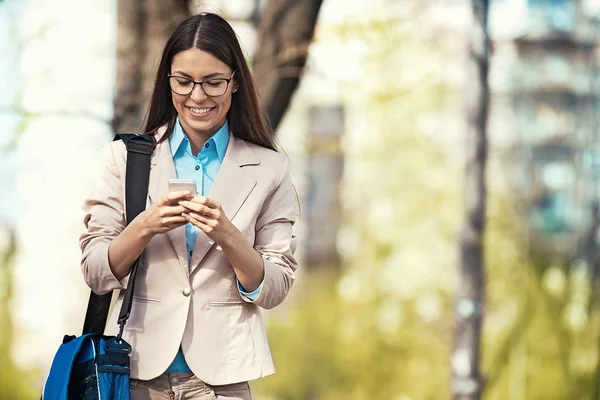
[0,0,600,400]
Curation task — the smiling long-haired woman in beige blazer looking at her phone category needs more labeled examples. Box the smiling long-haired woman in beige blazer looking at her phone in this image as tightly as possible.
[80,14,297,399]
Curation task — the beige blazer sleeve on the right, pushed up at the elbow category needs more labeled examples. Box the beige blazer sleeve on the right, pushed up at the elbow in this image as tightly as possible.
[245,157,298,309]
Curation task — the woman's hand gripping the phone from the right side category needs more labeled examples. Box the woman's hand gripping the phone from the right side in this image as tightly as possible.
[179,195,237,243]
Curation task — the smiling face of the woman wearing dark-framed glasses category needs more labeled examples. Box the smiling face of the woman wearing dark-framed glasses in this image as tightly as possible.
[170,48,237,141]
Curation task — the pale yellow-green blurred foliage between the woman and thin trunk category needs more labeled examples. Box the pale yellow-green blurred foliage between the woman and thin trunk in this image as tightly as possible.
[253,8,462,394]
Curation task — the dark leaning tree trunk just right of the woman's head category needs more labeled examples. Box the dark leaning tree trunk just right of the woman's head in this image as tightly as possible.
[253,0,323,129]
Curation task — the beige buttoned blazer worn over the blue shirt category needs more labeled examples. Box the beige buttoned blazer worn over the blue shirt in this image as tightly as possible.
[80,128,297,385]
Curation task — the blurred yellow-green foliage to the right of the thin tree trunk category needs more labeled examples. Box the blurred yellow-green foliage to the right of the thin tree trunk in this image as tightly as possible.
[484,201,600,400]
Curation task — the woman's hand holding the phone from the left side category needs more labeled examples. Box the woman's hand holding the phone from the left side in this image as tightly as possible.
[136,190,193,237]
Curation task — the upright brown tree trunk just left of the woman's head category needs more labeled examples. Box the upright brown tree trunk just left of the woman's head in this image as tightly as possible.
[112,0,189,132]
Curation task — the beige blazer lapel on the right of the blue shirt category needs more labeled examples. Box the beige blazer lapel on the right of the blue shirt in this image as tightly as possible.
[190,135,260,271]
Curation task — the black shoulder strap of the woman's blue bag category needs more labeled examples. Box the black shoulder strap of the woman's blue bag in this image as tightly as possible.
[83,134,156,334]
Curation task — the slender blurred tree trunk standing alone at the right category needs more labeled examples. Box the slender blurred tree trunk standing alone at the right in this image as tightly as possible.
[451,0,489,400]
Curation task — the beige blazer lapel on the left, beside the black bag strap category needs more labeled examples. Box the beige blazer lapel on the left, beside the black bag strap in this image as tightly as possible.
[148,127,188,276]
